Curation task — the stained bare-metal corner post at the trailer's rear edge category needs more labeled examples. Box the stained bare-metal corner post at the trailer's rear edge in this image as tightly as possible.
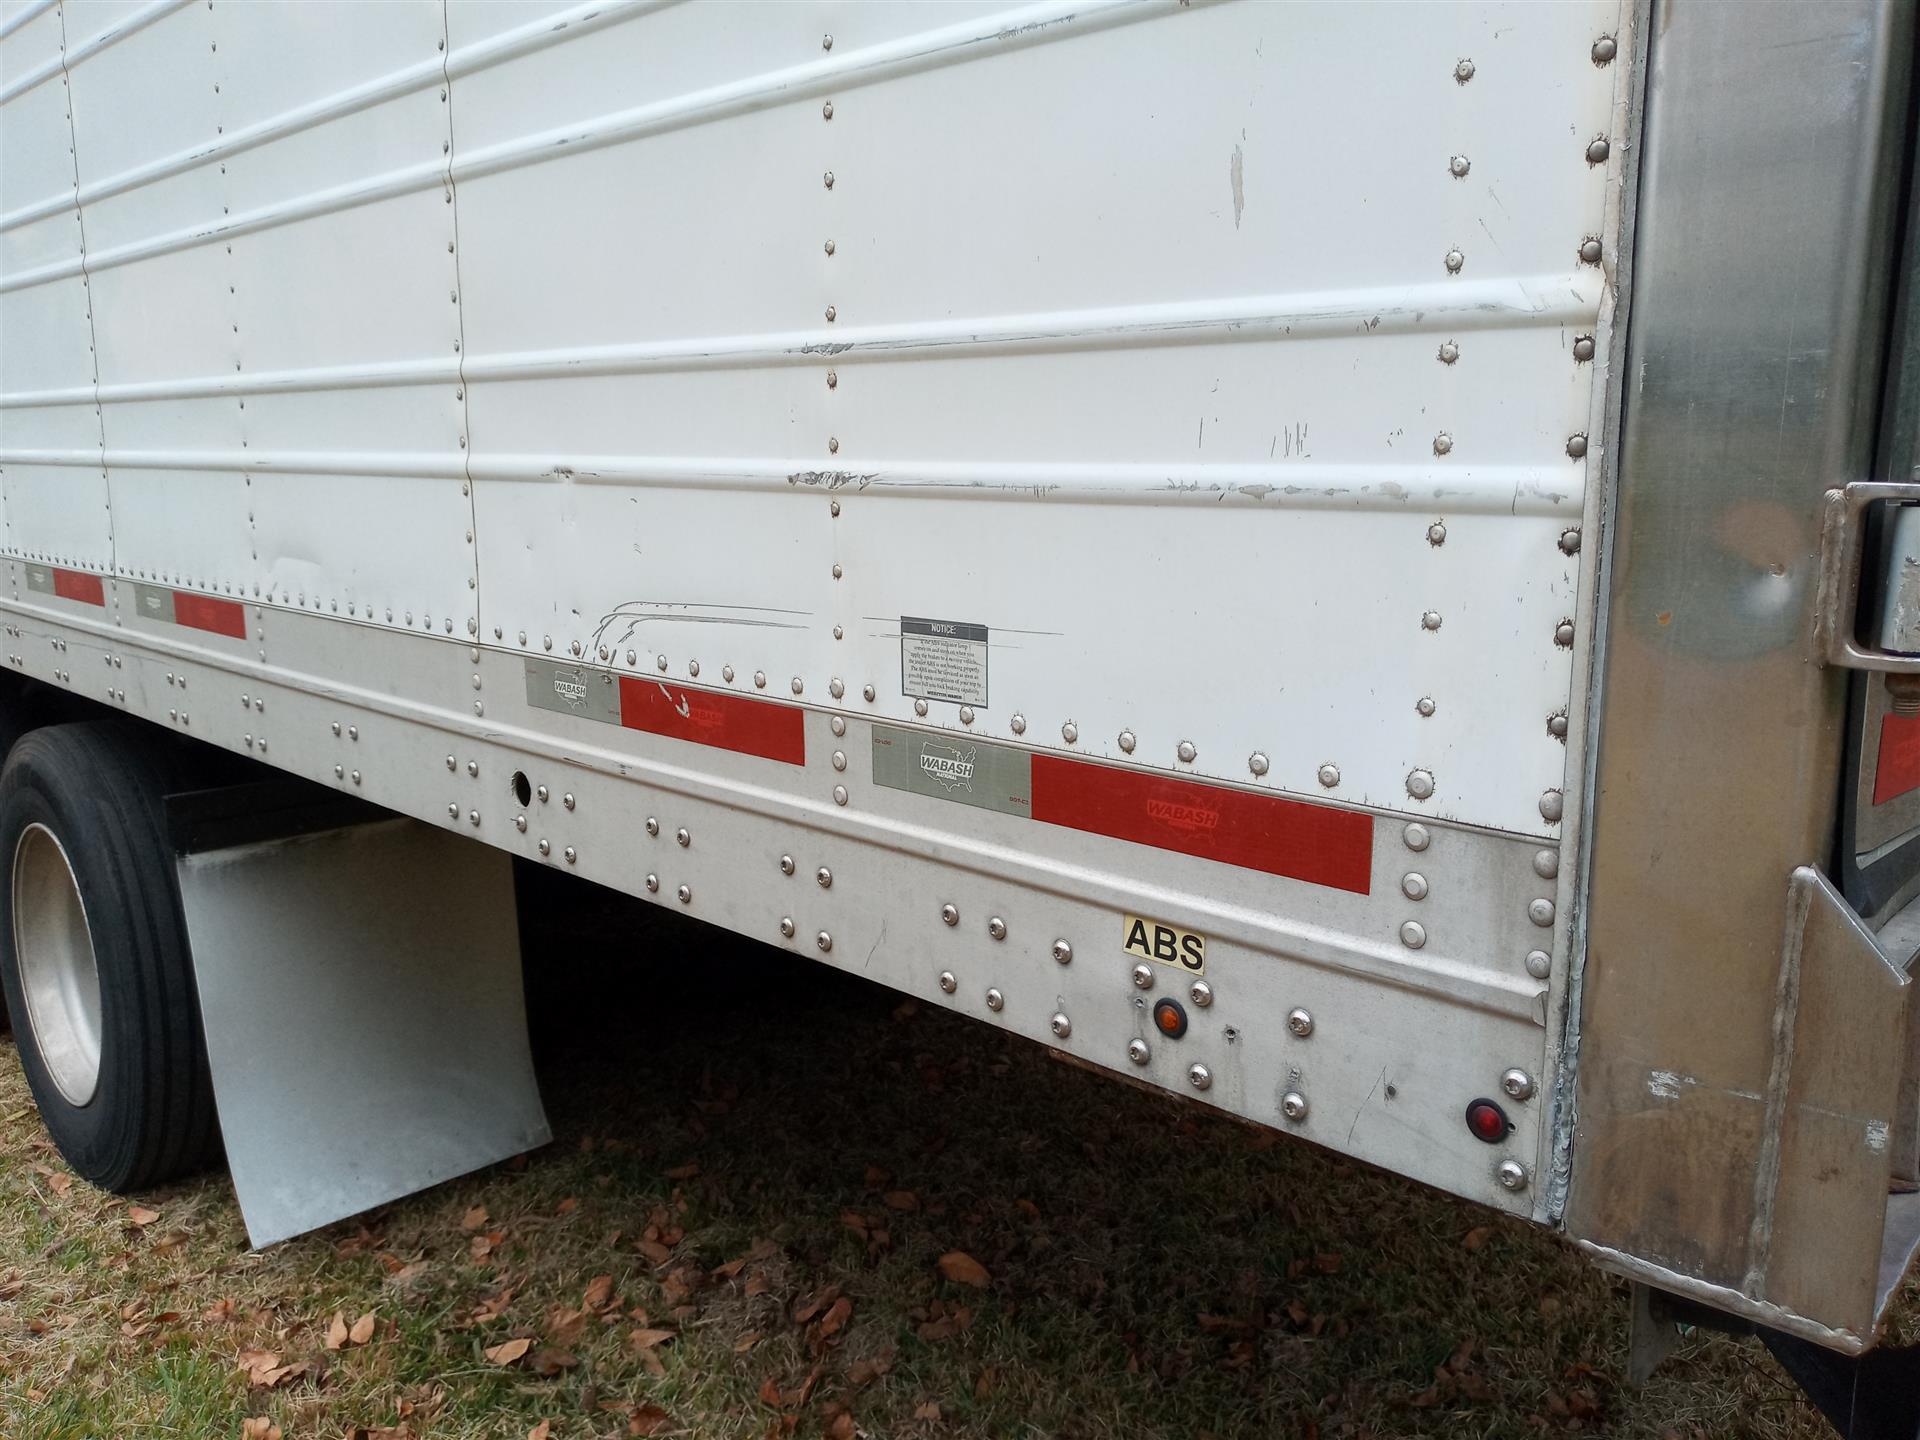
[1565,0,1914,1350]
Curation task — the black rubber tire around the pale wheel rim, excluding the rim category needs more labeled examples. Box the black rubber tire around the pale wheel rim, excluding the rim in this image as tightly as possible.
[0,722,219,1192]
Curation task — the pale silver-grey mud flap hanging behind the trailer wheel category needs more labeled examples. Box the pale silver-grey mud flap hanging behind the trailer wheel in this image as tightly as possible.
[179,820,551,1246]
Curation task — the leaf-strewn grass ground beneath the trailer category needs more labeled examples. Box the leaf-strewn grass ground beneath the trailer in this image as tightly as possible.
[0,875,1896,1440]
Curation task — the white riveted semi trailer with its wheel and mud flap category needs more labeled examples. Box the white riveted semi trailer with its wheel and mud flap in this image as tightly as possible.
[0,0,1920,1434]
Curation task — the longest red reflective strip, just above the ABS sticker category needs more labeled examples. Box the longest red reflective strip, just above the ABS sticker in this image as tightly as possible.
[1031,755,1373,895]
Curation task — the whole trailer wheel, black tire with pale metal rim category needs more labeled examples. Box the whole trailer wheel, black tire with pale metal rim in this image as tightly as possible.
[0,724,217,1190]
